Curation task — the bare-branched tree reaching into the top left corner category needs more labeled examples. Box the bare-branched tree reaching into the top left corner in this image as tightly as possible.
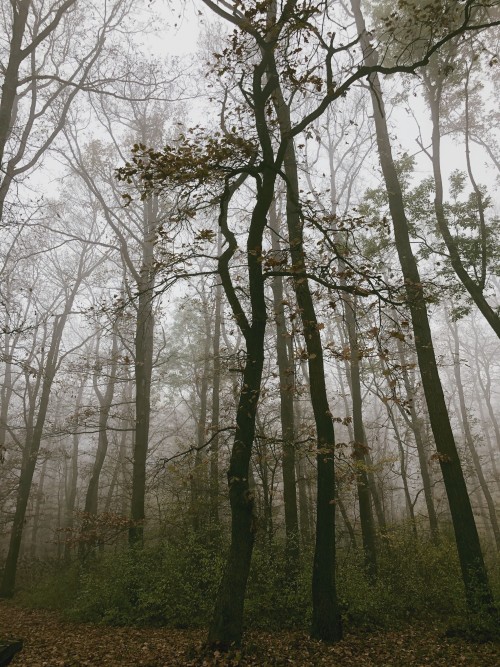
[0,0,136,220]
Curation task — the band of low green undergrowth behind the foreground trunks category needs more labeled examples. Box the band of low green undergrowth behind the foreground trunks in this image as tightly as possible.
[19,527,500,630]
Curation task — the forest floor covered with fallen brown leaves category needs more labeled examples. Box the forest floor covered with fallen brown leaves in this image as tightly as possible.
[0,601,500,667]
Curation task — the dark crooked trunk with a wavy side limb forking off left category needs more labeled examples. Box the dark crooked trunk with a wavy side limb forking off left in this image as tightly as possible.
[207,133,276,650]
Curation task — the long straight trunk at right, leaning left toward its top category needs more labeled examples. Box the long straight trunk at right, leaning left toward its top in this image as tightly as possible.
[351,0,496,614]
